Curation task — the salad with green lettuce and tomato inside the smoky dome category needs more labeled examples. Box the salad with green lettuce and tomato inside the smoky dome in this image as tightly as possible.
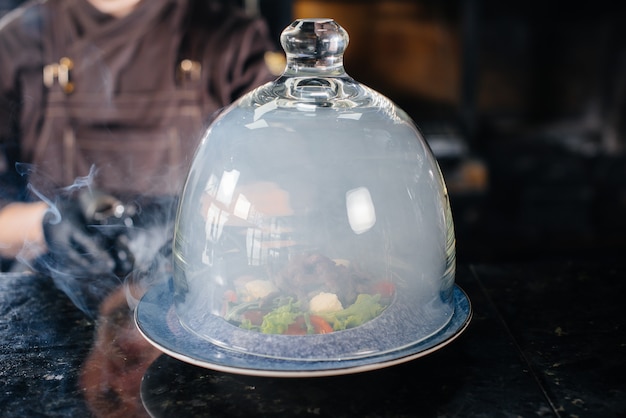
[224,254,395,335]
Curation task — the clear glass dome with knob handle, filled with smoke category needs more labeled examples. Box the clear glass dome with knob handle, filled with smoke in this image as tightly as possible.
[173,19,455,361]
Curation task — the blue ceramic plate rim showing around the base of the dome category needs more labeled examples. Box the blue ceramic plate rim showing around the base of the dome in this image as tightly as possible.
[135,285,472,377]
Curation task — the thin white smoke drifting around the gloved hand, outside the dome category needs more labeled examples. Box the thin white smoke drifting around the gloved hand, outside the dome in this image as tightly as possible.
[18,165,178,318]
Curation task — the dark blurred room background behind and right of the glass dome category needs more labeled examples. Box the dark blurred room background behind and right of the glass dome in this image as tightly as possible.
[0,0,626,262]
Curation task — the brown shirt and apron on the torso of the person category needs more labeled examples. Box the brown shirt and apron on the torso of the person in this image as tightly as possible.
[0,0,273,202]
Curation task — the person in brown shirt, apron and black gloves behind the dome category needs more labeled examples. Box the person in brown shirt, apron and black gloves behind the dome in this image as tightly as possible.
[0,0,274,310]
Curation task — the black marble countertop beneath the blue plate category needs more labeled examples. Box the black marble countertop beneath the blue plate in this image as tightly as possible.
[0,260,626,417]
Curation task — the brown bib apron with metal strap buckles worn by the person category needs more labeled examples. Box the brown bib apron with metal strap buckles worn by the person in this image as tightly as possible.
[30,0,206,195]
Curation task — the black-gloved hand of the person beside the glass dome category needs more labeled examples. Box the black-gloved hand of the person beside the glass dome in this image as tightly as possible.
[42,190,133,278]
